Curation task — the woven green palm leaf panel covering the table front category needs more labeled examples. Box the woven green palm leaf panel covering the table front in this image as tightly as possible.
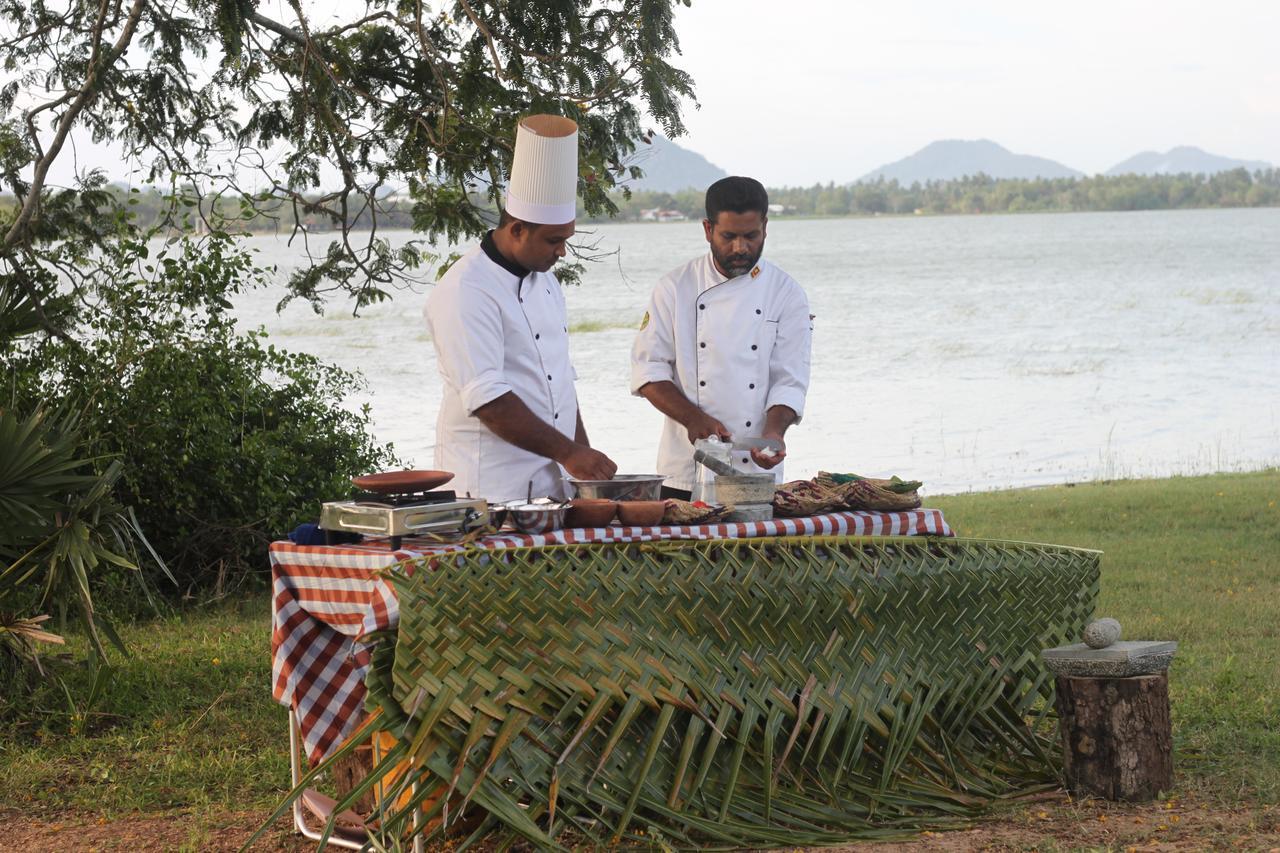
[370,537,1100,847]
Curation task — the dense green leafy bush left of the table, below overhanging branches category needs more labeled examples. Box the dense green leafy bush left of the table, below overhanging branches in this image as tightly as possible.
[9,230,392,589]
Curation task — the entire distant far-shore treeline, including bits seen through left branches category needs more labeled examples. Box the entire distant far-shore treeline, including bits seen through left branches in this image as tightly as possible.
[0,169,1280,233]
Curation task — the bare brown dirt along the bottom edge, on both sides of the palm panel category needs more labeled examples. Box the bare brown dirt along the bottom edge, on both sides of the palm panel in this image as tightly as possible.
[0,794,1280,853]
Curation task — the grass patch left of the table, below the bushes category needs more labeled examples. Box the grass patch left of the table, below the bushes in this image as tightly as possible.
[0,592,289,817]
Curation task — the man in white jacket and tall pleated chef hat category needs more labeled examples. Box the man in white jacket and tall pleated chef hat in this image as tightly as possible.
[425,115,617,501]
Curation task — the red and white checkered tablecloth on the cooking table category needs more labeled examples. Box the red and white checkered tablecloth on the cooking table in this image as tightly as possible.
[271,510,954,763]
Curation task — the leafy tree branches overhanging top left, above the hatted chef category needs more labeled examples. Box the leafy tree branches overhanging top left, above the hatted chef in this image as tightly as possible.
[0,0,691,307]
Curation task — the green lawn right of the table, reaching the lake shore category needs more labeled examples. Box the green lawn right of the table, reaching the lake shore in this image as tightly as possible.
[928,470,1280,806]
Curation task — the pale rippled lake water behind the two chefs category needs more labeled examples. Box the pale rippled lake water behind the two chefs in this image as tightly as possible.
[237,209,1280,493]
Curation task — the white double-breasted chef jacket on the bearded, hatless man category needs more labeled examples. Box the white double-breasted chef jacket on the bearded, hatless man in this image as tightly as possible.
[631,252,813,489]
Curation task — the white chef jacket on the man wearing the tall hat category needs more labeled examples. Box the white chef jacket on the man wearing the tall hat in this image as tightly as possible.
[424,239,577,501]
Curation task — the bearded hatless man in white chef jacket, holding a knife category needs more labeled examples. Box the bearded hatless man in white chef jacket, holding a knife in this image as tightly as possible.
[631,177,813,500]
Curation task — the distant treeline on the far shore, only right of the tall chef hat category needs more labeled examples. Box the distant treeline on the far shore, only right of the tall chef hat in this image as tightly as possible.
[593,169,1280,220]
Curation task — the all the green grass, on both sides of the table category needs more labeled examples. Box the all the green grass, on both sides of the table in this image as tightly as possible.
[0,470,1280,818]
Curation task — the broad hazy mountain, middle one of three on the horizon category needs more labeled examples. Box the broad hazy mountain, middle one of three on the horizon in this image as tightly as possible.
[859,140,1082,184]
